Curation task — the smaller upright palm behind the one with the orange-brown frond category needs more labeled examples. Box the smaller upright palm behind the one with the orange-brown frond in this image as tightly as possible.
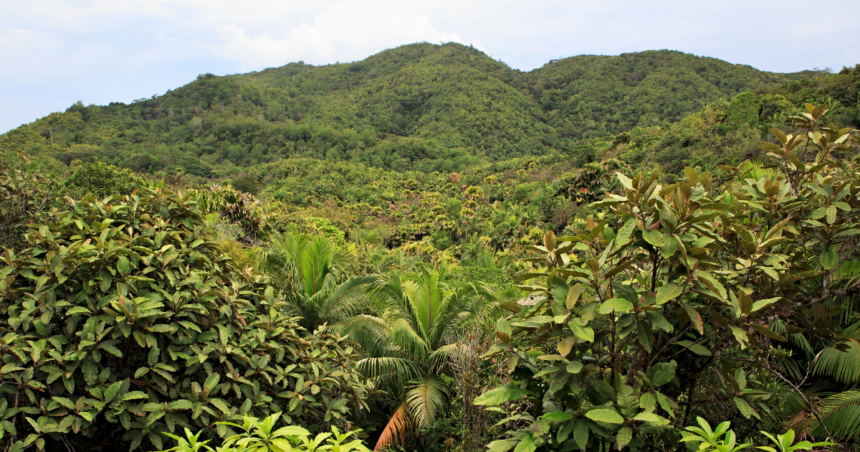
[257,231,381,331]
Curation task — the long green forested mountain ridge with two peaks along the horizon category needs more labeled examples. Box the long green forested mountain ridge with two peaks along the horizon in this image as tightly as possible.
[0,43,815,178]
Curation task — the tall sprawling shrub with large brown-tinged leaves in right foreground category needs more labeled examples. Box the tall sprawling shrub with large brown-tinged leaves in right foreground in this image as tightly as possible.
[476,105,860,451]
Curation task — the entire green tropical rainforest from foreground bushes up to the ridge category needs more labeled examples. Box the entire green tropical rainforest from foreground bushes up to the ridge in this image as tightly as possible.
[0,43,860,452]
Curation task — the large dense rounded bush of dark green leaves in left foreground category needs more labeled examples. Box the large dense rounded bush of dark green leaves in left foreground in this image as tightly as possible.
[0,190,366,450]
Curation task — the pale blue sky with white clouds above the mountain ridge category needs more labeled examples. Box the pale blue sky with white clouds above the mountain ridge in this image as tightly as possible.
[0,0,860,133]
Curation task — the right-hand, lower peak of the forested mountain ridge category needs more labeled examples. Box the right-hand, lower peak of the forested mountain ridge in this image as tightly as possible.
[526,50,816,138]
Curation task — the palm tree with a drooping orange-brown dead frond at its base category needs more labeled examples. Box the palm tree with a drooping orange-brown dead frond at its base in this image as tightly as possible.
[343,267,486,450]
